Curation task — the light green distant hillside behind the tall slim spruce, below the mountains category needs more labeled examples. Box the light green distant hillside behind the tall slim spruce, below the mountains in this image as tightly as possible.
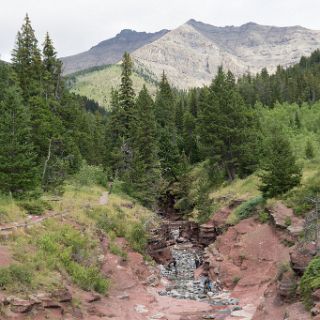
[67,65,156,109]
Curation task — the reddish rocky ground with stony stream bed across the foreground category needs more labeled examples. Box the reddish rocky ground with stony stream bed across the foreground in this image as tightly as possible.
[0,199,320,320]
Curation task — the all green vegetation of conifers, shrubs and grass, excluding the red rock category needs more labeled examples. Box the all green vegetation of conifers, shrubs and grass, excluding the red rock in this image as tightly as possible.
[0,12,320,320]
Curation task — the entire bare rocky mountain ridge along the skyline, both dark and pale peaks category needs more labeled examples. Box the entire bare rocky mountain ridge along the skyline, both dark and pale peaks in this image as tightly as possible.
[63,19,320,89]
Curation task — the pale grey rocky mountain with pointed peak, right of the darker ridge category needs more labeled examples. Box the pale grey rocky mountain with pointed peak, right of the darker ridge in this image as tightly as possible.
[132,20,320,88]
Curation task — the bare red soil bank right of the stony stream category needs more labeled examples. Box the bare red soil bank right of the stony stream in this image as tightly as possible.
[204,218,310,320]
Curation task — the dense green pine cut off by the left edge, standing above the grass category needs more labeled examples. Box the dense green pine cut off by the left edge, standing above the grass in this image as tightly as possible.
[0,86,40,197]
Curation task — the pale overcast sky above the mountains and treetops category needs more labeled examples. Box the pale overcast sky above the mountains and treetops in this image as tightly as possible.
[0,0,320,60]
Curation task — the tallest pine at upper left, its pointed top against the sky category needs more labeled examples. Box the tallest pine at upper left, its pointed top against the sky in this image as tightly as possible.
[12,15,43,102]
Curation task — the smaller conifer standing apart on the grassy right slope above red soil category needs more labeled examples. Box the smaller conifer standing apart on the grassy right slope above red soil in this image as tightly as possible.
[259,128,301,198]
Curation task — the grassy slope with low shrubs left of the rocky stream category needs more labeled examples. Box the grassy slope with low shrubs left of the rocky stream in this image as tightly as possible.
[0,166,157,294]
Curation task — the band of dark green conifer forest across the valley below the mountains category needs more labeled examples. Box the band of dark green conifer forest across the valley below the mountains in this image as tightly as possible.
[0,16,320,207]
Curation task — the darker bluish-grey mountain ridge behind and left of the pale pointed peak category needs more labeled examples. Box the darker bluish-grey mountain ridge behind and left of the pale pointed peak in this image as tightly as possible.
[61,29,169,74]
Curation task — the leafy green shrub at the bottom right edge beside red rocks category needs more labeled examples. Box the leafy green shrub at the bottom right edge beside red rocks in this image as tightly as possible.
[300,257,320,309]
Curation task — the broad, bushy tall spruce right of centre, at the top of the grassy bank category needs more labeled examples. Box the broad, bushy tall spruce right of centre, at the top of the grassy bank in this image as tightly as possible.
[199,68,258,180]
